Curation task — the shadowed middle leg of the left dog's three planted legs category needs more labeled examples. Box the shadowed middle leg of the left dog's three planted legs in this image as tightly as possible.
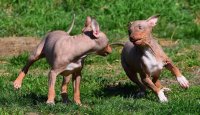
[61,76,71,104]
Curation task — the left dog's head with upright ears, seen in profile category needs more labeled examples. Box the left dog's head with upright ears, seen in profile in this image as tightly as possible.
[82,16,112,56]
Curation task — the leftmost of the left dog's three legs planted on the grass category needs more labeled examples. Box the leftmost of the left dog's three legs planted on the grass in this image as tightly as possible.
[47,70,57,104]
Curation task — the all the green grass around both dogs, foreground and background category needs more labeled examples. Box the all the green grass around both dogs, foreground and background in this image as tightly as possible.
[0,0,200,115]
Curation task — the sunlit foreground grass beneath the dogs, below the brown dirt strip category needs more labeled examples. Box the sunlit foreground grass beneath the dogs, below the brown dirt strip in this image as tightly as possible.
[0,40,200,115]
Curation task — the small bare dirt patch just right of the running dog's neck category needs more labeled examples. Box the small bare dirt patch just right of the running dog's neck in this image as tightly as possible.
[158,39,178,47]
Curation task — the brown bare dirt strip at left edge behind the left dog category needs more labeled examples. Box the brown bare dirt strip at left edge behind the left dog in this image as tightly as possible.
[0,37,41,57]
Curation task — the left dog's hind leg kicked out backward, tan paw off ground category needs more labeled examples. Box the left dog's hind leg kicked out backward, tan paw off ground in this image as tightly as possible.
[13,39,45,89]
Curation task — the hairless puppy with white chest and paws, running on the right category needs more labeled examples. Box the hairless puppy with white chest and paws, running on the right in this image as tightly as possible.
[121,15,189,102]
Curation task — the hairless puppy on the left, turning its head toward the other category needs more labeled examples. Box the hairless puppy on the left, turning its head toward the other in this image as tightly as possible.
[14,16,112,104]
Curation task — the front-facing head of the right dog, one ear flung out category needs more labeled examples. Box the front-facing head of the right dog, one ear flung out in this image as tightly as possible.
[128,15,159,46]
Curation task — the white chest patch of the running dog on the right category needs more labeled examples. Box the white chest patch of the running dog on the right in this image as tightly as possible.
[142,49,164,75]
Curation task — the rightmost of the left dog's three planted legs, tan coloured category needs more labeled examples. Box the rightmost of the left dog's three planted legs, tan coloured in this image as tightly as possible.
[72,71,81,105]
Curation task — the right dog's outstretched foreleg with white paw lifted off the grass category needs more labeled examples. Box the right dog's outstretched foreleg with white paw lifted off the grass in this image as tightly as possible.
[165,62,189,88]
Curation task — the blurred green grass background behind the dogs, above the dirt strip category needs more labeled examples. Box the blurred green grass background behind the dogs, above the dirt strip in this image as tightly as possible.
[0,0,200,41]
